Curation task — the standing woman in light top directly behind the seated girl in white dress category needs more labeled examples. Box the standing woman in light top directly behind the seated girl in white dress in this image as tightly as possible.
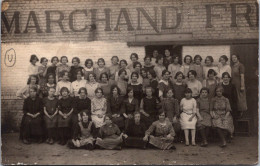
[187,70,202,99]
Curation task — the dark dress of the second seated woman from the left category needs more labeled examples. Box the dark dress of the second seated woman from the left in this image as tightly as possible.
[43,97,58,129]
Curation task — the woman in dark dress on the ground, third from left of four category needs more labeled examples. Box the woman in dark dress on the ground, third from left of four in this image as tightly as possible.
[123,112,147,149]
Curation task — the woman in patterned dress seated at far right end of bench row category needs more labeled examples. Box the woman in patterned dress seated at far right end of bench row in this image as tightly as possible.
[210,86,234,147]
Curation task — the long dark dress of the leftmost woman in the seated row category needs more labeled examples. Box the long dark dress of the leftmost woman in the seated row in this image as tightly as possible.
[20,97,43,139]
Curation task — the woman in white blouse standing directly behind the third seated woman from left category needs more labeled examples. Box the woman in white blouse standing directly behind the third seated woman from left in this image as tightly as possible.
[56,70,72,96]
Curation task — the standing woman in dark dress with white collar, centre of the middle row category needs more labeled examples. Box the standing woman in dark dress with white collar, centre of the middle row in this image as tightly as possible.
[127,72,143,103]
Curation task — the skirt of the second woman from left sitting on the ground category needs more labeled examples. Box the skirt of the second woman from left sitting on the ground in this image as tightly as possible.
[96,135,123,149]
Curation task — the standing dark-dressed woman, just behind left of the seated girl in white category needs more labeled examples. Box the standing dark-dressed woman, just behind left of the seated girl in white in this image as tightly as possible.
[172,71,187,102]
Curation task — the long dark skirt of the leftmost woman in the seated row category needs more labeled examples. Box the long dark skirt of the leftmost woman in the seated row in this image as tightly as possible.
[20,115,43,139]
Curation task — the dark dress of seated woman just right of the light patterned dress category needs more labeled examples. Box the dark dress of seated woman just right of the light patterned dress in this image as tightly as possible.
[107,96,125,129]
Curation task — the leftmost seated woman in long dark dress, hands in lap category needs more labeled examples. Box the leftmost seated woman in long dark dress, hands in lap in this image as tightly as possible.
[20,87,43,144]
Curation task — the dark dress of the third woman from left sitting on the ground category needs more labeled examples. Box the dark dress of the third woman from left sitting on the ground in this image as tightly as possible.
[125,121,147,148]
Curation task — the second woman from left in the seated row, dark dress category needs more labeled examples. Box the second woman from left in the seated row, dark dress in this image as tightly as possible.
[43,88,59,144]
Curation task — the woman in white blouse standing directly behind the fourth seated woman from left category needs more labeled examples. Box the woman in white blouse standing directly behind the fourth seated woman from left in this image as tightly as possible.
[71,69,86,97]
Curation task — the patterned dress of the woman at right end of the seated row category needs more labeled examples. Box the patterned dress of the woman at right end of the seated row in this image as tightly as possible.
[210,96,234,133]
